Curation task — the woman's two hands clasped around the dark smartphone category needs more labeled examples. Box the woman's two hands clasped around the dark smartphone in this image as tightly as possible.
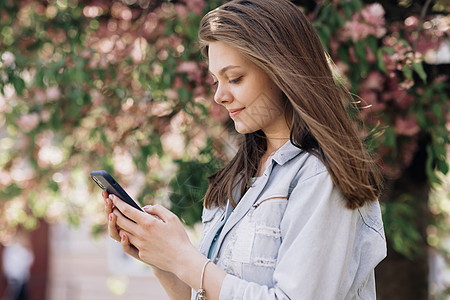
[106,195,198,273]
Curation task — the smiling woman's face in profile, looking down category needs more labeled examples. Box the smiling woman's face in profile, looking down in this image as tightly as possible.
[208,42,289,137]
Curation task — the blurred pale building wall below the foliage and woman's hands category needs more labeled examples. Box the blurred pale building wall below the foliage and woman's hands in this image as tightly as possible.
[48,220,169,300]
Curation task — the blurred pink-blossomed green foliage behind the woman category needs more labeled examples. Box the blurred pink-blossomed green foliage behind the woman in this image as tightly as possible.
[0,0,450,299]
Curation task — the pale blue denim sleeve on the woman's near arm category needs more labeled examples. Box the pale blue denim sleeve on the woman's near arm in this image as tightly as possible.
[220,171,386,300]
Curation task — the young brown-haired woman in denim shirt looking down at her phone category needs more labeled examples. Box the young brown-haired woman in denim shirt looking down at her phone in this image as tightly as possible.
[103,0,386,300]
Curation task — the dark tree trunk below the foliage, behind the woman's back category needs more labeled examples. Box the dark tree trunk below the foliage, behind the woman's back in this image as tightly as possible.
[376,139,430,300]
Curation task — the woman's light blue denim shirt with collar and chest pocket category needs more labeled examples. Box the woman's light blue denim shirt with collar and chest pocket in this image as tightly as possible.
[192,142,386,300]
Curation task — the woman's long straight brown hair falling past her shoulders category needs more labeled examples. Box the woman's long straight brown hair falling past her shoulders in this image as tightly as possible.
[199,0,382,209]
